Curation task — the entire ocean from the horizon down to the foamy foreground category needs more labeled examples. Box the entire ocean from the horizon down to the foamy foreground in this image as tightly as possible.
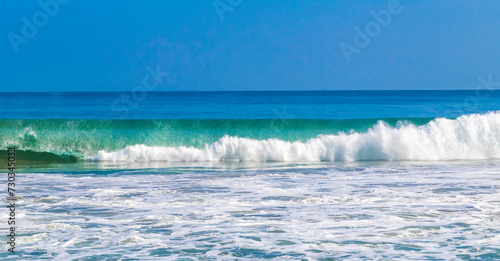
[0,90,500,260]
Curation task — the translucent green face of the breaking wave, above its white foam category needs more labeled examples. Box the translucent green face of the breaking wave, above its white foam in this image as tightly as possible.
[0,118,432,159]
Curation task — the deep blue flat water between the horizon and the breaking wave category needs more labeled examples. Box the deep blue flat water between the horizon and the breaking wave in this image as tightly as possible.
[0,90,500,119]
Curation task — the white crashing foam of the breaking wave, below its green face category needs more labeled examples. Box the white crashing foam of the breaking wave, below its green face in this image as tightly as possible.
[92,112,500,162]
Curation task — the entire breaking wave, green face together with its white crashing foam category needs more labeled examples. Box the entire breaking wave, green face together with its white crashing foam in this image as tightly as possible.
[4,112,500,162]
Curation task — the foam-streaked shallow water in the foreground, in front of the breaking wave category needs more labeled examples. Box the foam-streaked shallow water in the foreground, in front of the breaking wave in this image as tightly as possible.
[0,162,500,260]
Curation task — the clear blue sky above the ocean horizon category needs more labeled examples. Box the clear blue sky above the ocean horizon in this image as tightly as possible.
[0,0,500,91]
